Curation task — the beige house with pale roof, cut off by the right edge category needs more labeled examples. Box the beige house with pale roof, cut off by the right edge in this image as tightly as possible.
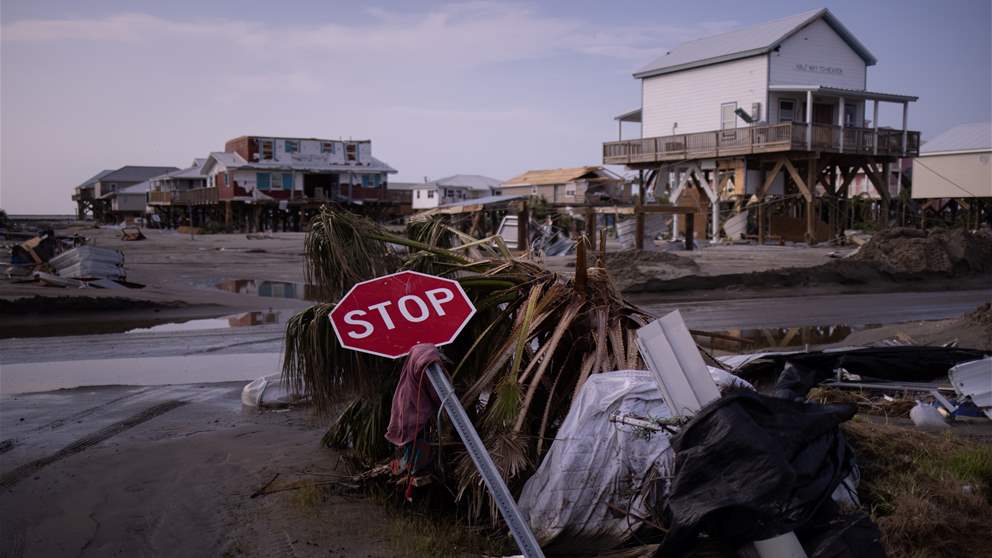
[913,122,992,199]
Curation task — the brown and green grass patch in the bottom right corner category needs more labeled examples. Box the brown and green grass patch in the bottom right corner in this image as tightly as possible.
[844,420,992,558]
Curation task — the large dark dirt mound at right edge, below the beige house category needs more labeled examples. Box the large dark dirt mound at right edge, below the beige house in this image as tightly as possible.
[853,228,992,275]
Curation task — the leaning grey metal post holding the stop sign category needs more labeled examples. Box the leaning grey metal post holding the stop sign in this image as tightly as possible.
[427,364,544,558]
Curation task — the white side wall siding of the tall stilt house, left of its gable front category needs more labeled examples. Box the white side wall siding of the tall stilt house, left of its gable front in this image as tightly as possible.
[641,55,768,138]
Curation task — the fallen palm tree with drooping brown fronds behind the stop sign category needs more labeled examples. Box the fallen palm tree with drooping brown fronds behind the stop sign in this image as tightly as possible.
[283,208,649,517]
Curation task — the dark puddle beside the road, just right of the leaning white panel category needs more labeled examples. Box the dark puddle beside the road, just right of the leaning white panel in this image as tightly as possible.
[695,324,881,352]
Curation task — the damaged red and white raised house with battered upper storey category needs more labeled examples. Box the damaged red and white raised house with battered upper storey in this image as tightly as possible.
[144,136,397,230]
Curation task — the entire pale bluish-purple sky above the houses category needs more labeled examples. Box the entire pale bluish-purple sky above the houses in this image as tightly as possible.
[0,0,992,214]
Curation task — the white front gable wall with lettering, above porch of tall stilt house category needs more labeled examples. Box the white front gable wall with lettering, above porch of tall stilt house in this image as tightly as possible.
[769,19,866,89]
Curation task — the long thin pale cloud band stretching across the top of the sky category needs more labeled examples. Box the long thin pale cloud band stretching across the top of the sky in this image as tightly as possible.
[2,2,733,66]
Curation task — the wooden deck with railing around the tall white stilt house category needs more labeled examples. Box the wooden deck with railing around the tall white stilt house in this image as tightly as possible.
[603,122,920,165]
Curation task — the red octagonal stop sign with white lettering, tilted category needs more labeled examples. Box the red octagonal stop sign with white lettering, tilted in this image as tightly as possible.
[330,271,475,358]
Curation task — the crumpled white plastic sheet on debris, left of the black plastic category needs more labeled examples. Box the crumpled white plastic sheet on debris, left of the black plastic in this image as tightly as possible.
[518,368,749,553]
